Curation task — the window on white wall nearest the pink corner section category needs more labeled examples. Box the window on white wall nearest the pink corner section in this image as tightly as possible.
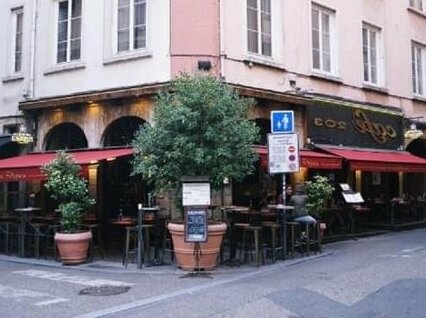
[117,0,146,52]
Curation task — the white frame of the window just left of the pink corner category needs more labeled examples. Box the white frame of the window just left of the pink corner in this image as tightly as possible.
[112,0,149,55]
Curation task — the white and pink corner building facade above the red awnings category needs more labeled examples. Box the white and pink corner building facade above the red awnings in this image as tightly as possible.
[0,0,426,214]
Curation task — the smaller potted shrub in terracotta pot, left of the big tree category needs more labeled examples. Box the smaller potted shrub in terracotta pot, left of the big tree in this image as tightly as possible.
[42,151,95,264]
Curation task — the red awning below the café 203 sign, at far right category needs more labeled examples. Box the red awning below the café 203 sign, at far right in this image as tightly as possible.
[320,147,426,172]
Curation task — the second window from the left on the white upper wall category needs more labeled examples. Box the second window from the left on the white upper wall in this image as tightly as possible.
[56,0,82,63]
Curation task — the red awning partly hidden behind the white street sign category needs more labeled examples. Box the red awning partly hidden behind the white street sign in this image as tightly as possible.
[256,146,342,170]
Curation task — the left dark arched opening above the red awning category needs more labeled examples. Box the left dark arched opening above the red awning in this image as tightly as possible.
[43,122,88,150]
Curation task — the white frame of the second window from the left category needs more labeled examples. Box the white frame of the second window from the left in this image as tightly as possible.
[54,0,84,64]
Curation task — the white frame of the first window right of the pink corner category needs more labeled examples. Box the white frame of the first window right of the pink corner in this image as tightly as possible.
[245,0,274,59]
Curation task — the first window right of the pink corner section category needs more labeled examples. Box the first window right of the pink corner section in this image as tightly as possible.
[247,0,272,56]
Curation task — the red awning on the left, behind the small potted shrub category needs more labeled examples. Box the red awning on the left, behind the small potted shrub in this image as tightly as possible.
[0,148,133,182]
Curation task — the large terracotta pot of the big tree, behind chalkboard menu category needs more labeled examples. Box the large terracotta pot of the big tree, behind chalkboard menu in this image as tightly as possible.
[167,222,226,271]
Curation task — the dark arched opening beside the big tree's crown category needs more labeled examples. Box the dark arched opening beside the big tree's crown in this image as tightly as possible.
[101,116,146,147]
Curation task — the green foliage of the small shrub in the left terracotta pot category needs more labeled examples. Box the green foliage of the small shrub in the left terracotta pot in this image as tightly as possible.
[41,150,95,233]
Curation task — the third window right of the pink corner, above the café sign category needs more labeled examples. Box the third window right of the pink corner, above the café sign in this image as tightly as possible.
[362,24,380,85]
